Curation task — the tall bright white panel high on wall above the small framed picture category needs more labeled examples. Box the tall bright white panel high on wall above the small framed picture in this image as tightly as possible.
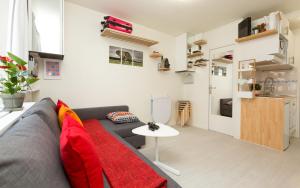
[30,0,64,54]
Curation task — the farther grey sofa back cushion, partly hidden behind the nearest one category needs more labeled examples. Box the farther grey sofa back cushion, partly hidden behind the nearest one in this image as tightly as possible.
[22,98,60,140]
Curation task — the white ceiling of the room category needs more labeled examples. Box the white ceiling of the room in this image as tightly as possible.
[66,0,300,35]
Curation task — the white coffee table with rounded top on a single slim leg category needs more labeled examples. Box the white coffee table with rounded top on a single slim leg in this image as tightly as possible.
[132,123,180,176]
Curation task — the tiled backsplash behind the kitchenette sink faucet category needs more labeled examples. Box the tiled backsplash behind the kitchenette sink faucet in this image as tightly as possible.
[256,70,298,95]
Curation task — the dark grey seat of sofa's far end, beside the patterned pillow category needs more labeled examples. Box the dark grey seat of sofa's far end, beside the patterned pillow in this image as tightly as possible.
[100,120,145,138]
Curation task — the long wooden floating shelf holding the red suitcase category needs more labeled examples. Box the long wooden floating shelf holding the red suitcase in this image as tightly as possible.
[101,28,158,47]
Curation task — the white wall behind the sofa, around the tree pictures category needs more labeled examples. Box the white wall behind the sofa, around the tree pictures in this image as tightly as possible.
[38,2,183,123]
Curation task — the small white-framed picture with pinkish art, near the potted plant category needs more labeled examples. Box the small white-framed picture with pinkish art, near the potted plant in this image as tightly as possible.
[44,59,62,80]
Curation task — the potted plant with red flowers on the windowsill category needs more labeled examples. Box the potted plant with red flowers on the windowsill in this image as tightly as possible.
[0,53,38,111]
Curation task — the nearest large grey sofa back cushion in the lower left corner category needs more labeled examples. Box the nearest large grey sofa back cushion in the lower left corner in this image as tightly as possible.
[0,114,70,188]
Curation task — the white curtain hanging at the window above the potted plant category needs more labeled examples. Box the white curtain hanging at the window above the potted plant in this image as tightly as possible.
[7,0,29,60]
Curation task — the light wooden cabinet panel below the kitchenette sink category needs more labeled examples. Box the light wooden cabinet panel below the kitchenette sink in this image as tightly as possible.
[241,97,290,150]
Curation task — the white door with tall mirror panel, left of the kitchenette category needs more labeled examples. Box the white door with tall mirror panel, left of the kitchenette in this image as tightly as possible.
[209,46,234,136]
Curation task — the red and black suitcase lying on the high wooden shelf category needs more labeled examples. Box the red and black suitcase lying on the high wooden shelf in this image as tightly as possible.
[101,16,132,34]
